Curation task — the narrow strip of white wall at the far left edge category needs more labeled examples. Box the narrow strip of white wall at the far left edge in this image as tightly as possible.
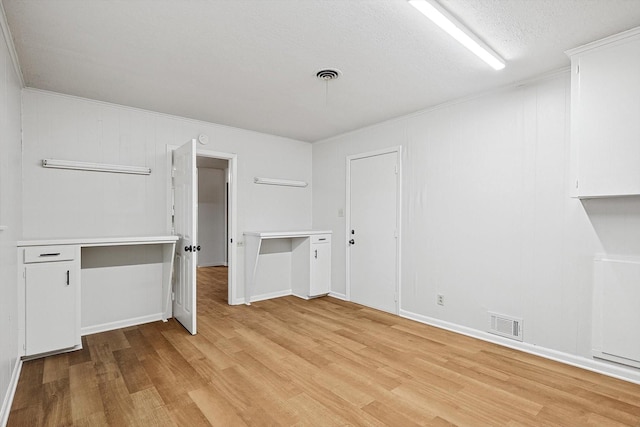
[0,15,22,425]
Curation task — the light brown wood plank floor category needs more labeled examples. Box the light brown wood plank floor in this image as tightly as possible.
[9,268,640,427]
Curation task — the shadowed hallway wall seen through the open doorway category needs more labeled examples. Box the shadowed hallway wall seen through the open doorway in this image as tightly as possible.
[198,168,227,267]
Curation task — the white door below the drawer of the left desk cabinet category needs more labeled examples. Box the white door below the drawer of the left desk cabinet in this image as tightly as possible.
[25,262,80,355]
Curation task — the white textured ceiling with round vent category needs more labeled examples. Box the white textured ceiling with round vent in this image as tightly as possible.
[1,0,640,141]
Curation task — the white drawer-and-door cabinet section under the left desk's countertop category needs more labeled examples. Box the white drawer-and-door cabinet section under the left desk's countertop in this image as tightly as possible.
[21,246,81,356]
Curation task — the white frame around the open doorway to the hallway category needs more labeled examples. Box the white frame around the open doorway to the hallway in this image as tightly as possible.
[166,144,242,305]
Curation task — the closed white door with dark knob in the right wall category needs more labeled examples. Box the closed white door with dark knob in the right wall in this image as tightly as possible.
[347,151,399,313]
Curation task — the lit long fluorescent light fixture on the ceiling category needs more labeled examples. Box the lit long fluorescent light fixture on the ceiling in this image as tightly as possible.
[409,0,505,70]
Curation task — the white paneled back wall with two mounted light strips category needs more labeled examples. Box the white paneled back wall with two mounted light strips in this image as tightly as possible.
[23,89,311,320]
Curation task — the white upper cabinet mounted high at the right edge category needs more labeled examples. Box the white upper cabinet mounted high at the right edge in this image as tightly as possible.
[567,27,640,198]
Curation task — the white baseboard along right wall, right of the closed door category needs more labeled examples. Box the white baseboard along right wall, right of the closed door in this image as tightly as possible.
[400,310,640,384]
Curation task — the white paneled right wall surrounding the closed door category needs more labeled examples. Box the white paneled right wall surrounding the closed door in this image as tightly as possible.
[313,73,640,381]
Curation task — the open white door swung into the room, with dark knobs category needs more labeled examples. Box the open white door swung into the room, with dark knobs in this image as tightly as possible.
[173,139,198,335]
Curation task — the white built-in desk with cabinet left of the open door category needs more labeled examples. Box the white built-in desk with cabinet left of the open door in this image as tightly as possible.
[17,236,178,357]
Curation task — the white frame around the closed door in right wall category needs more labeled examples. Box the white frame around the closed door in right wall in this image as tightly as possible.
[344,145,402,314]
